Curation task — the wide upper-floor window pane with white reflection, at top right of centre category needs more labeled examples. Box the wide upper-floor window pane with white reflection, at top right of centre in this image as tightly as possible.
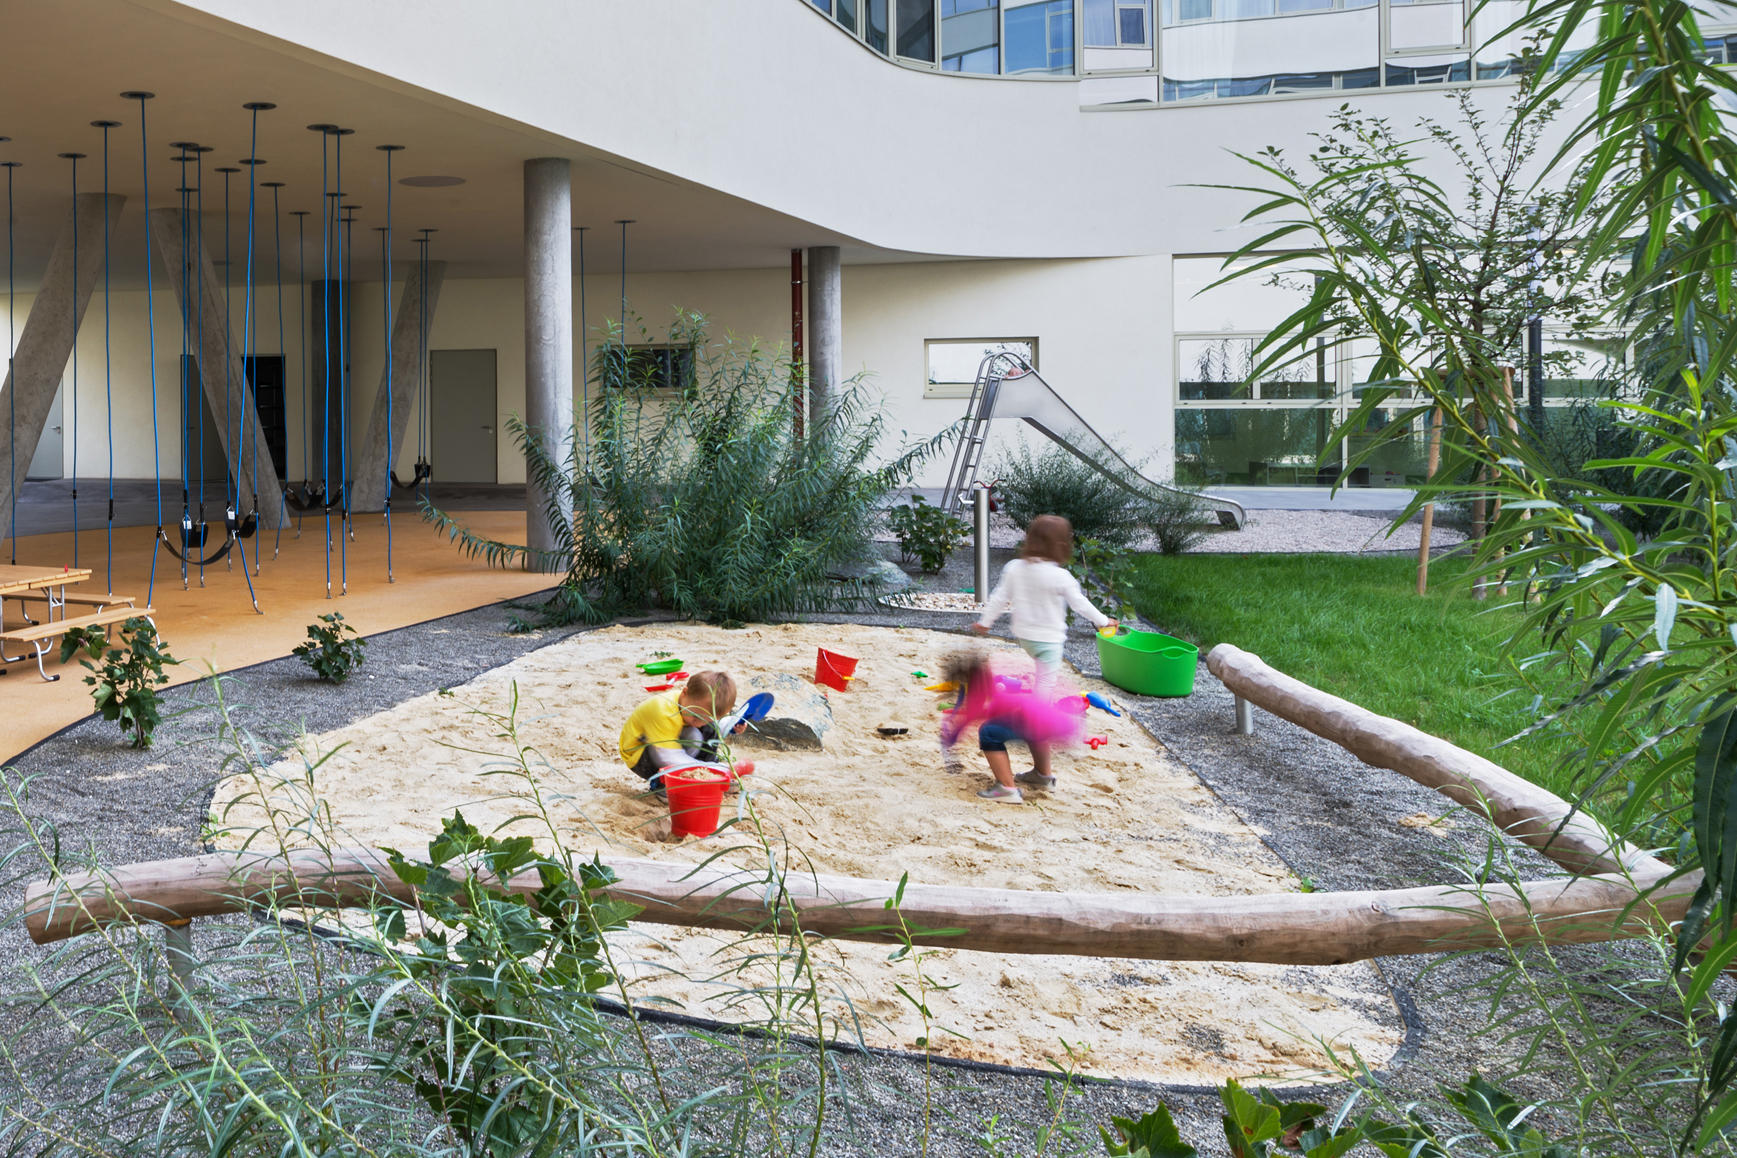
[1162,0,1381,101]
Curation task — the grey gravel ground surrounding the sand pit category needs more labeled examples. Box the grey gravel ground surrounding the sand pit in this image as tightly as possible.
[0,545,1591,1156]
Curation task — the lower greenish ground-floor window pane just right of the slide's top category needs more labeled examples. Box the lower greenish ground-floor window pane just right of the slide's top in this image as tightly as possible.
[1176,406,1339,486]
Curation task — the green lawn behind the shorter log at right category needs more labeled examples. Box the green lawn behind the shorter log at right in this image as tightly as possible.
[1136,556,1574,797]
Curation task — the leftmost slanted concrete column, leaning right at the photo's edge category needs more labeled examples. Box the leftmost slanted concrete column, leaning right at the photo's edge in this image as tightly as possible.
[0,193,127,536]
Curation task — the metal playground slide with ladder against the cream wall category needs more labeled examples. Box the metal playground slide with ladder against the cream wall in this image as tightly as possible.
[941,351,1245,530]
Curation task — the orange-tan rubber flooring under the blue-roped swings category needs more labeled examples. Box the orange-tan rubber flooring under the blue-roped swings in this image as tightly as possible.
[0,510,554,760]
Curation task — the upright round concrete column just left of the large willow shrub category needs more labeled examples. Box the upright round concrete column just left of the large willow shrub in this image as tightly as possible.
[525,156,573,569]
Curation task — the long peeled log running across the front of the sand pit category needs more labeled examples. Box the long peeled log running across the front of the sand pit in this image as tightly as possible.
[24,849,1695,965]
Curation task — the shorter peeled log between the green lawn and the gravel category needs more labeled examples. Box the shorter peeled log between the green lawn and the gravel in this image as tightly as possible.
[1205,644,1673,880]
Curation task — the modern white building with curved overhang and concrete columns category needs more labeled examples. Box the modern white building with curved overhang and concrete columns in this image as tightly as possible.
[0,0,1667,538]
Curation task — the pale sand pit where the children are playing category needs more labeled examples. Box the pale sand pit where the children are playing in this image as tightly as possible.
[214,625,1403,1082]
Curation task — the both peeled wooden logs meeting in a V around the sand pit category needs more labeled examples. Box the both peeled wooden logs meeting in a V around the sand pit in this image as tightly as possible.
[24,644,1699,965]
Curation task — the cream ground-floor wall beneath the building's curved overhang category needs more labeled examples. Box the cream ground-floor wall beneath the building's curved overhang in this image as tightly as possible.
[0,257,1174,484]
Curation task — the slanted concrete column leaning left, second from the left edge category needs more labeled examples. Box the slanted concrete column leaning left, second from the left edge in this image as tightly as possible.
[148,208,288,531]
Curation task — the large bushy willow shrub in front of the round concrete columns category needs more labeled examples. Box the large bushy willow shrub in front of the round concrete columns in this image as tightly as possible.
[426,316,945,623]
